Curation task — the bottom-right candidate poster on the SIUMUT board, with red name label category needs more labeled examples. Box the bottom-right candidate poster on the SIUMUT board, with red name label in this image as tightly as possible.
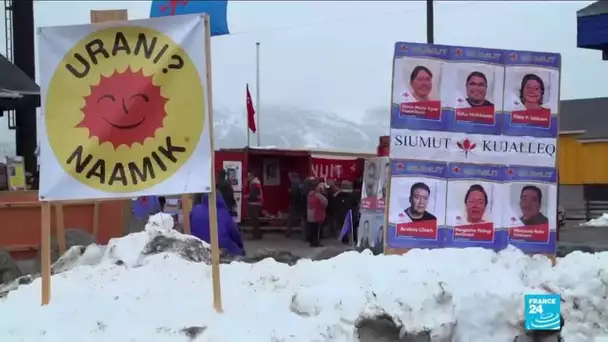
[503,166,557,253]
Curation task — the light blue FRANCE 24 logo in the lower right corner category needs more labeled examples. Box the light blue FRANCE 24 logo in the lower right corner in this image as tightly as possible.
[524,294,561,331]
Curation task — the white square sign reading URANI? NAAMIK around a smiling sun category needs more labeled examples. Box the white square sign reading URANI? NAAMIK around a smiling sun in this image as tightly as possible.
[37,15,213,201]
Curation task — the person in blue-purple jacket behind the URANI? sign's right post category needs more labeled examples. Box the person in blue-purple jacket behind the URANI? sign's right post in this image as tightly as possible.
[190,193,245,255]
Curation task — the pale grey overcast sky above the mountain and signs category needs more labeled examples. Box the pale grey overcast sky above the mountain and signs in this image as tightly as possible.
[1,1,608,150]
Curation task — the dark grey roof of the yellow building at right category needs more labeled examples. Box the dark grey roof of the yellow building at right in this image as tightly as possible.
[559,97,608,141]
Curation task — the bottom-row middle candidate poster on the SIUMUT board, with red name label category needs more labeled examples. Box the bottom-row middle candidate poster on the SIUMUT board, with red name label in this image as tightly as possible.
[445,163,505,249]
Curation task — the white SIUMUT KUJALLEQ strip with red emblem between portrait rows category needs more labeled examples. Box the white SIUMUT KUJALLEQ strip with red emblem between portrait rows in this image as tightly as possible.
[391,128,557,167]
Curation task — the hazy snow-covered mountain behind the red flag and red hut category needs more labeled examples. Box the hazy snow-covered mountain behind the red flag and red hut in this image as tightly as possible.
[213,105,389,152]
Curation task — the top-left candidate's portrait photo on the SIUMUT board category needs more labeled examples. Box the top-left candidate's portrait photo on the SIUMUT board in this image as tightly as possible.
[393,58,442,103]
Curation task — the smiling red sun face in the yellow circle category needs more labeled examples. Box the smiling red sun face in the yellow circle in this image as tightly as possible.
[77,69,167,149]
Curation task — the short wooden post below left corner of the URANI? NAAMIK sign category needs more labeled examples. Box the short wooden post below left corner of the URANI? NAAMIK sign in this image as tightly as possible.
[40,202,51,305]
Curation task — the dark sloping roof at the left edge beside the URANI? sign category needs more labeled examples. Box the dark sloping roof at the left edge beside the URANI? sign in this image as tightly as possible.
[0,54,40,111]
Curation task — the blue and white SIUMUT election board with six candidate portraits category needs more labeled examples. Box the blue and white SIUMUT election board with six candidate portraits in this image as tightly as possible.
[386,42,561,254]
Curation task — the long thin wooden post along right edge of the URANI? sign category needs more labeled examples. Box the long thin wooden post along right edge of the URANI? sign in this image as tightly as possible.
[203,14,223,313]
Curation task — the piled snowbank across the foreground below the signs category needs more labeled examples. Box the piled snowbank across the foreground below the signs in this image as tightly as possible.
[0,217,608,342]
